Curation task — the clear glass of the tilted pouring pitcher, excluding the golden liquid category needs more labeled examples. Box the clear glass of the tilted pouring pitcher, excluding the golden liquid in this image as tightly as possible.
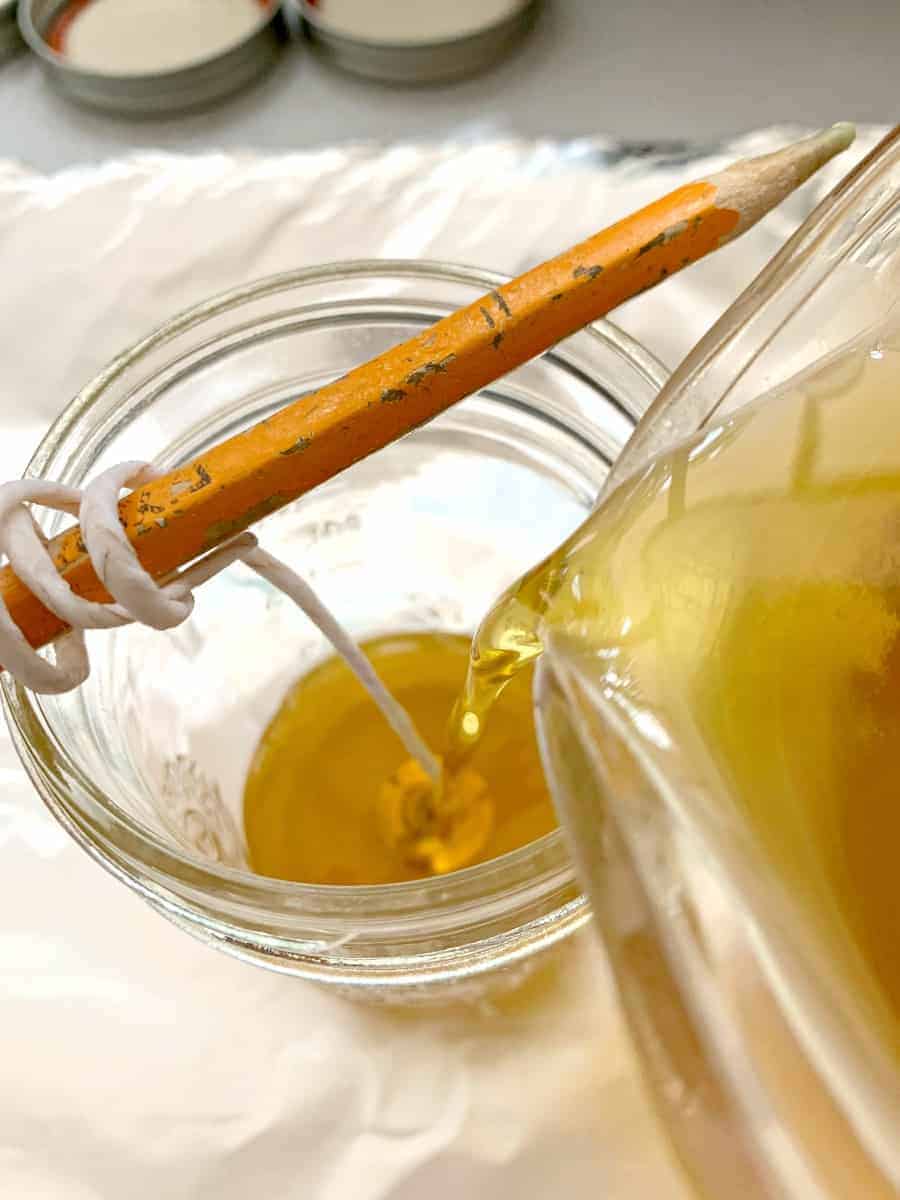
[536,133,900,1200]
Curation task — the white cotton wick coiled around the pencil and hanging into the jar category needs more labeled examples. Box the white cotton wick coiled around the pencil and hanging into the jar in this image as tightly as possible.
[0,462,440,784]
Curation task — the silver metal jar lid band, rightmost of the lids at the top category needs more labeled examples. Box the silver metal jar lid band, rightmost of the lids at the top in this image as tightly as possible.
[296,0,539,84]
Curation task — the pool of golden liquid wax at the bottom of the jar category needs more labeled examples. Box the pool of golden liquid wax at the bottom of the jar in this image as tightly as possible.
[244,632,556,883]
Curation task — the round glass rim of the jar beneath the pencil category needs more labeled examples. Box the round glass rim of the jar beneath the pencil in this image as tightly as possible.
[0,259,668,923]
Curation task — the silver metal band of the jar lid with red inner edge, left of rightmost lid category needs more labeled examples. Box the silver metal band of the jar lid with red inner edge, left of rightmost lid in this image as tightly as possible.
[19,0,286,116]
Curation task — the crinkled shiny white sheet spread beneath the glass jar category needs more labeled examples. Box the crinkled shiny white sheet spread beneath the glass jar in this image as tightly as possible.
[0,130,877,1200]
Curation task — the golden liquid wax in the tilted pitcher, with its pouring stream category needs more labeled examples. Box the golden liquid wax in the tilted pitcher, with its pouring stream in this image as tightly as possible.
[454,333,900,1046]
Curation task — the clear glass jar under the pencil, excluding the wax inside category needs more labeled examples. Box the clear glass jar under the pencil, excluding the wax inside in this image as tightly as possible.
[2,263,665,998]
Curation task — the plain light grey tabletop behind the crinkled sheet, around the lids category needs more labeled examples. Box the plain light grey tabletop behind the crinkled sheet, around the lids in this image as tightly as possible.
[0,0,900,170]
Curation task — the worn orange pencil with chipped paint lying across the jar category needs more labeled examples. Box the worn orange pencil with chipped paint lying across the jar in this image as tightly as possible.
[0,125,853,647]
